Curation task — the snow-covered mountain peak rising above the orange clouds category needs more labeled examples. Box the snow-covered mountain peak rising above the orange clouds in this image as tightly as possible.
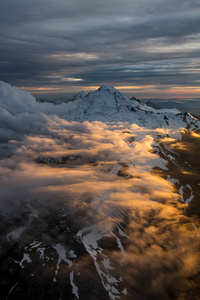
[45,86,200,129]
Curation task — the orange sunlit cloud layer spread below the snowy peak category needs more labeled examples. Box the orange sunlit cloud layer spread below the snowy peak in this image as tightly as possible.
[0,112,199,299]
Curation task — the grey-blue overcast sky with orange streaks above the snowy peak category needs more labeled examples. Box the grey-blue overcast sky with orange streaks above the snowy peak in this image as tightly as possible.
[0,0,200,99]
